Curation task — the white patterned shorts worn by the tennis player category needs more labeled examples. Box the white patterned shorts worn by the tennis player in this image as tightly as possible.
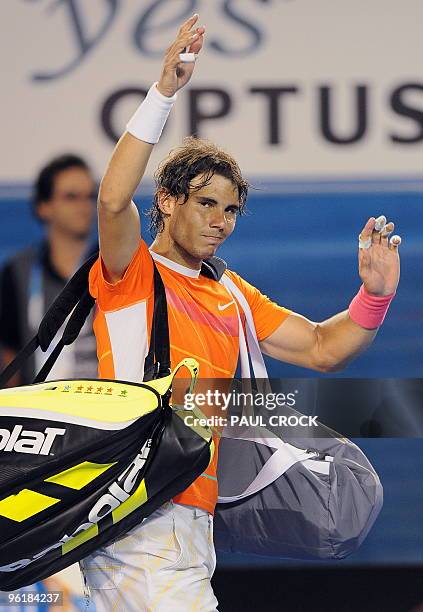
[80,501,217,612]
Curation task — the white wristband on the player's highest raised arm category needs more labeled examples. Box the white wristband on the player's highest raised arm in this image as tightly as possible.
[126,82,176,144]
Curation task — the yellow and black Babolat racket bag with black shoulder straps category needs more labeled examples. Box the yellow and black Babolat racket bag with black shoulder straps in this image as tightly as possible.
[0,253,213,590]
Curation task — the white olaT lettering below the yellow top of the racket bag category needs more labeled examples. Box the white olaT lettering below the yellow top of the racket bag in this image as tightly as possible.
[0,425,66,455]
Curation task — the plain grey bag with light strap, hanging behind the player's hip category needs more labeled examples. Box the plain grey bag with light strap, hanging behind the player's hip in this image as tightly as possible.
[214,392,383,560]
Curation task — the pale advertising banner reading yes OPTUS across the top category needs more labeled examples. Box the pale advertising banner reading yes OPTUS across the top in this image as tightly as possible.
[0,0,423,184]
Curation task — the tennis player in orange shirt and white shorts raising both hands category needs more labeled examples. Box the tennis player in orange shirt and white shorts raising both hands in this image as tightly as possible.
[82,15,400,612]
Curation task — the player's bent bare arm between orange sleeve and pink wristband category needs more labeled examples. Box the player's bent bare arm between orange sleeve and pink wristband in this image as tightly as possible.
[260,311,377,372]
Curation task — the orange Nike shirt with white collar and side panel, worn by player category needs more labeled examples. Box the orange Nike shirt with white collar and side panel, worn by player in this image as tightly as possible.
[89,240,290,513]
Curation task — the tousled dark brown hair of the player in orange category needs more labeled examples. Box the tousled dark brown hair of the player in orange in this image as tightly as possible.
[145,136,250,236]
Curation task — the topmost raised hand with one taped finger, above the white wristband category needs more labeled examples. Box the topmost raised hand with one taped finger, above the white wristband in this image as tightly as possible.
[157,14,205,97]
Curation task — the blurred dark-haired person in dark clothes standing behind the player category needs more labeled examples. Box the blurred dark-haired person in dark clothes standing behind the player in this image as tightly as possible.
[0,154,97,386]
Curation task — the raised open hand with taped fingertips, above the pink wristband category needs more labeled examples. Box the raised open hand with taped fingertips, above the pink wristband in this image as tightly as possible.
[358,215,401,295]
